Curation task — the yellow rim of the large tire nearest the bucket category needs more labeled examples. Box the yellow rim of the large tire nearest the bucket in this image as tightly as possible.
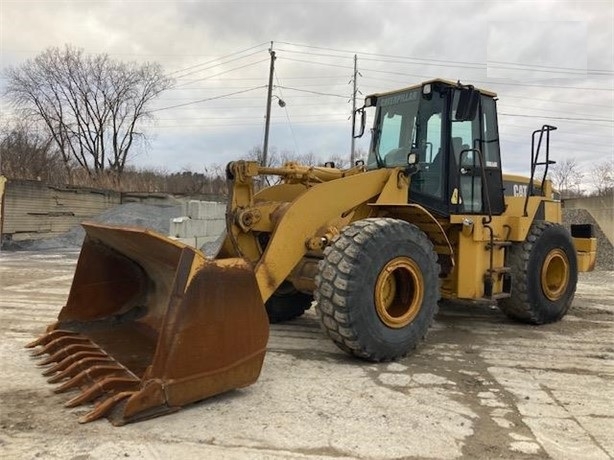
[375,257,424,329]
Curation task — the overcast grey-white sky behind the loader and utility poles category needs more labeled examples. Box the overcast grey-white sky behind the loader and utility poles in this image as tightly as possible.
[0,0,614,183]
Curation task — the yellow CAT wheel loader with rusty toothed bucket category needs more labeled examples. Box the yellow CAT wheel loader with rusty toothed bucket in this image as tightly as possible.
[29,79,596,425]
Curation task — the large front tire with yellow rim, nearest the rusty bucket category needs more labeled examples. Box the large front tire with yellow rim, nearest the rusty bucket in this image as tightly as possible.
[314,218,440,362]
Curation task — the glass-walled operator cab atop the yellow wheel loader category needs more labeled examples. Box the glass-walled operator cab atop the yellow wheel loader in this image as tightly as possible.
[363,80,505,216]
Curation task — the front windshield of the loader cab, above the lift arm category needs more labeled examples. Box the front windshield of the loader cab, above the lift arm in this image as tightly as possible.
[367,89,421,169]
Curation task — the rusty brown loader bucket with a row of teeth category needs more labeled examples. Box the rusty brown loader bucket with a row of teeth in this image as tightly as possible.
[27,223,268,425]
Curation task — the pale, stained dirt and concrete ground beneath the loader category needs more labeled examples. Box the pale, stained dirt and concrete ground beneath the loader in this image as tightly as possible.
[0,252,614,460]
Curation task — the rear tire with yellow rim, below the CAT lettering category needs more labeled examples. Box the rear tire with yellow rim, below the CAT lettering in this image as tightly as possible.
[499,221,578,324]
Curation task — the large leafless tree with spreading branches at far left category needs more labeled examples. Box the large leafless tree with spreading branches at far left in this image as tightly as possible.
[6,45,172,181]
